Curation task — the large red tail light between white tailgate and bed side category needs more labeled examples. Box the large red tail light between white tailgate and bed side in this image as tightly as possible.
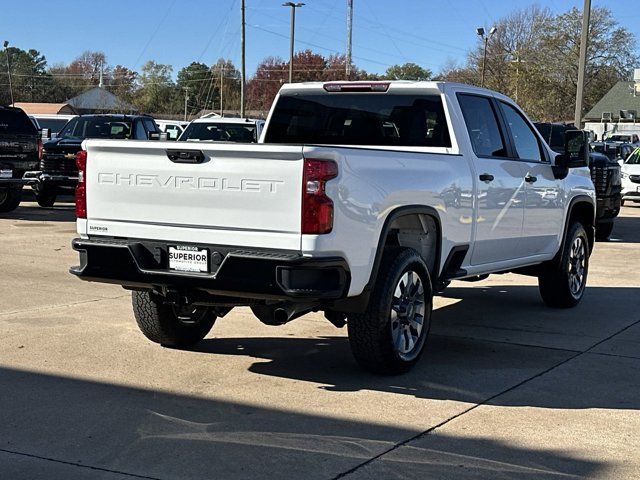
[302,158,338,235]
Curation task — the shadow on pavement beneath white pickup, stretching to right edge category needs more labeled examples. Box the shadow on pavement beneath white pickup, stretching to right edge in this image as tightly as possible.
[195,286,640,409]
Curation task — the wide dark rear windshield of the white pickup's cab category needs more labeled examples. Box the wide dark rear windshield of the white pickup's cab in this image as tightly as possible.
[265,93,451,147]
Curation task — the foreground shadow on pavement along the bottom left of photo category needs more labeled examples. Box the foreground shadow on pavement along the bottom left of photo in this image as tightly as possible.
[0,368,608,480]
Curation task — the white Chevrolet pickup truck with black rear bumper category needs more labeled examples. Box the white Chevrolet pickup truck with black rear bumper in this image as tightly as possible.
[71,82,595,374]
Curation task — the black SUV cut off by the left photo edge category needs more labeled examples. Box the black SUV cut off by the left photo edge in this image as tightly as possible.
[0,106,42,212]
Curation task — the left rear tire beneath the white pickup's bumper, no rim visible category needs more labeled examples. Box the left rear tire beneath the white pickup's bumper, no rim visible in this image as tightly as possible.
[131,292,216,347]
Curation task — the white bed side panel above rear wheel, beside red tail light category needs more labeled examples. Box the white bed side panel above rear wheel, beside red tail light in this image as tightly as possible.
[302,146,473,295]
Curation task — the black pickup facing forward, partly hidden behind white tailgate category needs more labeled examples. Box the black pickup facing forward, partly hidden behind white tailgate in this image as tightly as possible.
[25,114,160,207]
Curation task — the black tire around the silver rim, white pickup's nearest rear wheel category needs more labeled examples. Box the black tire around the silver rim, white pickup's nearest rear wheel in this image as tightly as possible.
[347,247,433,375]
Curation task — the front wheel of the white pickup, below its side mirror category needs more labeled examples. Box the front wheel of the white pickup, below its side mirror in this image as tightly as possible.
[538,222,590,308]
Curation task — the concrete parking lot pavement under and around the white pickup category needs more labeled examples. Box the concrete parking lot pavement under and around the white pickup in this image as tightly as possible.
[0,196,640,480]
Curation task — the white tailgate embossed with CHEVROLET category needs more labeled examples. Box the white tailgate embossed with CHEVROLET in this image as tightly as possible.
[79,140,303,250]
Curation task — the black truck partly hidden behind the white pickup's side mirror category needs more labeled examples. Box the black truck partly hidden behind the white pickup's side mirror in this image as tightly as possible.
[535,123,622,240]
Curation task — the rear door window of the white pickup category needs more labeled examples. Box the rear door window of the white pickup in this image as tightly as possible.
[458,94,507,157]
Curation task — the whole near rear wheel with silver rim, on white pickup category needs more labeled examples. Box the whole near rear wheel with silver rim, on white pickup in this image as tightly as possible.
[347,248,433,375]
